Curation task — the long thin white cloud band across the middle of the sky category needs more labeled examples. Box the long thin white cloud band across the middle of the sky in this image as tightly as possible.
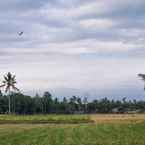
[1,39,144,55]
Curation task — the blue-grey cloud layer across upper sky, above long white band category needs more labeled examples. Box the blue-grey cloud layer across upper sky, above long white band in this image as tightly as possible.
[0,0,145,54]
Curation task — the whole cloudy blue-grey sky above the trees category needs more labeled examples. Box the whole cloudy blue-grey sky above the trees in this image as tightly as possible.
[0,0,145,99]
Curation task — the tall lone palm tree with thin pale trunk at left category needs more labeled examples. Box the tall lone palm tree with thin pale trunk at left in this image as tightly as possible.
[0,72,19,114]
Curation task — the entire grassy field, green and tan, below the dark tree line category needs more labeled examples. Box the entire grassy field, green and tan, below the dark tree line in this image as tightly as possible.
[0,115,145,145]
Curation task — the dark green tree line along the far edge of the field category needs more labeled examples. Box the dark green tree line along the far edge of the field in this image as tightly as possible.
[0,92,145,114]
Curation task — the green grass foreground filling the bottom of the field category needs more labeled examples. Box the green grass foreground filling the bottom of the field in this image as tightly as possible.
[0,123,145,145]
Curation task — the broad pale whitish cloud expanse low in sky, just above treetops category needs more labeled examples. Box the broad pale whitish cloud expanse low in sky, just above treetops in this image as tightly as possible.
[0,54,145,98]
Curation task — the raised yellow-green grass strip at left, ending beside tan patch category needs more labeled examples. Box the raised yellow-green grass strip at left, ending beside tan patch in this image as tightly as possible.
[0,115,93,124]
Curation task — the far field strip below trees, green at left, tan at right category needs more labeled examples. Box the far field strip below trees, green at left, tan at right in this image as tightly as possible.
[0,114,145,124]
